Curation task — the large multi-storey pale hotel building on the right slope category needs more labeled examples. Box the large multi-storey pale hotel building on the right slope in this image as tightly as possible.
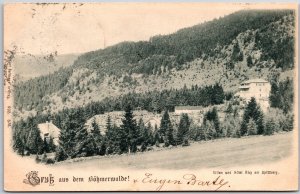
[235,79,271,112]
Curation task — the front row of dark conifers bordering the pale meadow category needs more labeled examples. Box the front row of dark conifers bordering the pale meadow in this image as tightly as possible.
[13,98,293,161]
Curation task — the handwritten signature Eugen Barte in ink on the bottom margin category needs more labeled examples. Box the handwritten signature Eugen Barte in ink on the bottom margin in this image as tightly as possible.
[141,173,230,191]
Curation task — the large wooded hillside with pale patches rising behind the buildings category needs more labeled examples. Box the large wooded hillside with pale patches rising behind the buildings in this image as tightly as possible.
[14,10,295,116]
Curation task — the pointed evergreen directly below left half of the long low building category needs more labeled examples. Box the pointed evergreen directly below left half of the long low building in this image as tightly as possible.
[176,113,190,145]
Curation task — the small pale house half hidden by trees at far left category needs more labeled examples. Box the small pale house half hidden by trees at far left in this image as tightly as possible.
[38,121,60,145]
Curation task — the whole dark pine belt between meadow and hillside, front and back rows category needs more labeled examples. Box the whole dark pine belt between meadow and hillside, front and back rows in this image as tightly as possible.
[13,79,293,163]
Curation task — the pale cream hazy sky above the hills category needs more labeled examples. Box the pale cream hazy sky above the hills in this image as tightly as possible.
[4,3,296,54]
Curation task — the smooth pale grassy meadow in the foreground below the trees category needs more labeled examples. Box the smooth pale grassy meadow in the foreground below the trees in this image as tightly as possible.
[55,132,293,169]
